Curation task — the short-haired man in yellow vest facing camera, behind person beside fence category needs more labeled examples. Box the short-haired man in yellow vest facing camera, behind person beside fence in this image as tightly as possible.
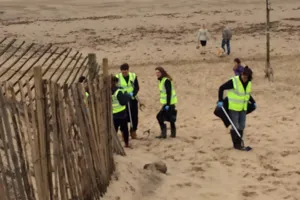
[116,63,140,139]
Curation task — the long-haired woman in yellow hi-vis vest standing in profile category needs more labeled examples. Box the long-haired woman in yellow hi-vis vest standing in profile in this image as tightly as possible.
[155,67,177,138]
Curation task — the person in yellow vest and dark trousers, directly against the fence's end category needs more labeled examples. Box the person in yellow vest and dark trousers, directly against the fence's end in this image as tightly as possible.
[111,76,130,147]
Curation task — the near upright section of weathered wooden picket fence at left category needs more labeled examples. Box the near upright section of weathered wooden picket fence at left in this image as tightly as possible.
[0,63,125,200]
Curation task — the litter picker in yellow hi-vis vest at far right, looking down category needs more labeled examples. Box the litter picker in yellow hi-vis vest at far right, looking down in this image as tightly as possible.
[217,66,256,150]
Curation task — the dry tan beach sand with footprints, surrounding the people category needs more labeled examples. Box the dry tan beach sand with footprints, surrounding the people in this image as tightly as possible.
[0,0,300,200]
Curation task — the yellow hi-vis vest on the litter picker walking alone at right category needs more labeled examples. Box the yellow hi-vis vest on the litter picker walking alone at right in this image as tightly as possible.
[227,76,252,111]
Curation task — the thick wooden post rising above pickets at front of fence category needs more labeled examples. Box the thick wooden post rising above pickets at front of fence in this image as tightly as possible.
[34,67,50,200]
